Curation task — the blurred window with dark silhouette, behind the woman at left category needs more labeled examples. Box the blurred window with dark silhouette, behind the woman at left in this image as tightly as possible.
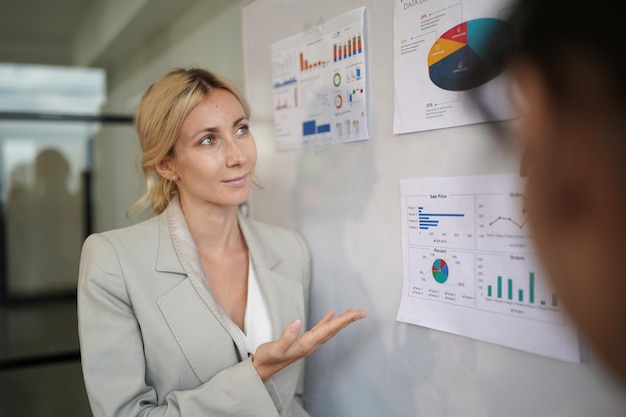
[0,64,106,300]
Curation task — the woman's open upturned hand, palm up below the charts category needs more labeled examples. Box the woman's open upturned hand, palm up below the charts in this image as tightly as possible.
[252,308,367,381]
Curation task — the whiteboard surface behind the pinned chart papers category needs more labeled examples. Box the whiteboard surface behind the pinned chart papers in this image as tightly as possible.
[242,0,626,417]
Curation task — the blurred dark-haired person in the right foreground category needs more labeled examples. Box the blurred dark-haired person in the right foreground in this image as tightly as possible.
[490,0,626,384]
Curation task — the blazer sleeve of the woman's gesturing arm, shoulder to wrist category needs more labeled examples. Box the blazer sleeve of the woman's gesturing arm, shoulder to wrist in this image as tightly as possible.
[78,235,279,417]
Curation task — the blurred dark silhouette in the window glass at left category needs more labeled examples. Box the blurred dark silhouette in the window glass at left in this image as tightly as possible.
[7,148,85,296]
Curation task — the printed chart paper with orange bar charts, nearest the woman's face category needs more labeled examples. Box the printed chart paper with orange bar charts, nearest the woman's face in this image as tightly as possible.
[272,7,369,150]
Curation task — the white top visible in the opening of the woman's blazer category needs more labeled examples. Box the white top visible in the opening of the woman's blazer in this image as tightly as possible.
[242,260,272,353]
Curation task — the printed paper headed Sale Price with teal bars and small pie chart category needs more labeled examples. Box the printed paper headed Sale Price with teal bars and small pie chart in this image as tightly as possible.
[397,174,580,362]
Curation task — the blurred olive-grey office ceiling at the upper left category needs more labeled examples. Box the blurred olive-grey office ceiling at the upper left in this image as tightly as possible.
[0,0,212,69]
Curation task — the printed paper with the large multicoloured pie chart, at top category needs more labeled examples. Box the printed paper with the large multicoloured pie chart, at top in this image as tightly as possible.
[393,0,513,134]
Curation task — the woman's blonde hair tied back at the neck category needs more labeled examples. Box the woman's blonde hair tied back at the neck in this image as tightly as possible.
[126,68,250,215]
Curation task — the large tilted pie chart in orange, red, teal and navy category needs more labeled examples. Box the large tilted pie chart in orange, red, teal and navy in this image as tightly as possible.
[428,18,513,91]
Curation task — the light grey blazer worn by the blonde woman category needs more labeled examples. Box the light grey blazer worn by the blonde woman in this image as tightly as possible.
[78,199,311,417]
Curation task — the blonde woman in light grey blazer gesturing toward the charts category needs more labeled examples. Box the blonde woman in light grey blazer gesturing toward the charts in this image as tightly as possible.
[78,69,365,417]
